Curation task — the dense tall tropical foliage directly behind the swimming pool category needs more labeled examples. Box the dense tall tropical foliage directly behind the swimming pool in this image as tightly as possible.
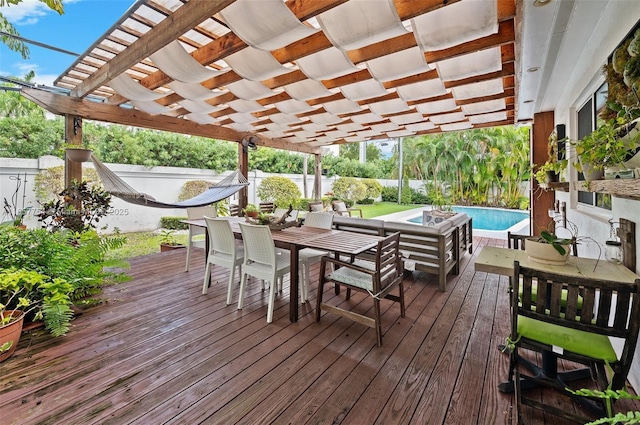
[393,127,530,208]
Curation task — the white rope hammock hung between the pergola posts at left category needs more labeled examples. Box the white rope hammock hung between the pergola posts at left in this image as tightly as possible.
[91,155,249,208]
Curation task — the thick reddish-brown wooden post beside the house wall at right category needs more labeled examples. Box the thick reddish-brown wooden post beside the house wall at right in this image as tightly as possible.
[530,112,556,235]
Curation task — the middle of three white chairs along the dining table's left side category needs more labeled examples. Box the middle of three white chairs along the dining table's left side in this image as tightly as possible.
[202,216,244,305]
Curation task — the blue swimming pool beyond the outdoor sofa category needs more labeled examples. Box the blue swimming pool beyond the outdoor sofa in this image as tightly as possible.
[403,206,530,239]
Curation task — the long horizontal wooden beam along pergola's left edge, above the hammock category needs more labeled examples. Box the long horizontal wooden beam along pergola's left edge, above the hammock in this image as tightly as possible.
[21,88,320,154]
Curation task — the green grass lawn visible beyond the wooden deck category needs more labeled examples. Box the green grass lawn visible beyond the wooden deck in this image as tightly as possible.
[106,202,420,260]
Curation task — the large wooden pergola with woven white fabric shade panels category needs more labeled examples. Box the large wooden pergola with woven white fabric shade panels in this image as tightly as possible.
[23,0,553,212]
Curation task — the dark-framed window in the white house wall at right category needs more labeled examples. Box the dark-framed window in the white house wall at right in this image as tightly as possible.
[578,83,611,210]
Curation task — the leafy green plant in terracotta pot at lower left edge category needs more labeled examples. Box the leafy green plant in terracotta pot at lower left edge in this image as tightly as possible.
[0,269,73,361]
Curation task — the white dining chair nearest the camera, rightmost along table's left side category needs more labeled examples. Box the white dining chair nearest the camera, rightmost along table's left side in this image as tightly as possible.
[238,223,291,323]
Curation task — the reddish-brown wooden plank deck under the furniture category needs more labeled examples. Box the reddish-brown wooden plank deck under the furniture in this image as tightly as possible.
[0,238,640,425]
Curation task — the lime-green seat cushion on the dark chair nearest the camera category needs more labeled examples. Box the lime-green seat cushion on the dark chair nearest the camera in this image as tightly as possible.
[518,316,618,362]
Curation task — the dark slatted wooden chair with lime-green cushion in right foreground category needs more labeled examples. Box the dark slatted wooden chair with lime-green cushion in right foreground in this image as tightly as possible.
[508,261,640,423]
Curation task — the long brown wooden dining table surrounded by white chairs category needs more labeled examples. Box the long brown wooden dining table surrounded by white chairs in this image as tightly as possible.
[182,217,382,322]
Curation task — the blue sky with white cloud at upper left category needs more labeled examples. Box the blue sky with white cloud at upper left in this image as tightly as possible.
[0,0,135,86]
